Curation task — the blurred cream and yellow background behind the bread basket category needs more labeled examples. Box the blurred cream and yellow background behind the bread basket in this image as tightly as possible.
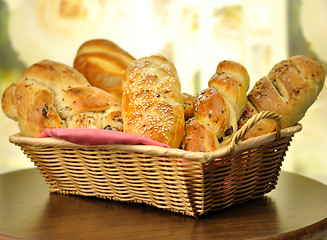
[0,0,327,183]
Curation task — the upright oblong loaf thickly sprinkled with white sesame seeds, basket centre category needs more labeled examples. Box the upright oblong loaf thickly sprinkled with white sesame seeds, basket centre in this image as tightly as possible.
[122,55,185,148]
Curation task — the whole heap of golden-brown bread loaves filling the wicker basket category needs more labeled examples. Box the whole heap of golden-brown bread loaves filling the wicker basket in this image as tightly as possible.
[2,39,325,152]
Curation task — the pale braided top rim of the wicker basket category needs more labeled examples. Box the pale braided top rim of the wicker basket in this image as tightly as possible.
[9,123,302,163]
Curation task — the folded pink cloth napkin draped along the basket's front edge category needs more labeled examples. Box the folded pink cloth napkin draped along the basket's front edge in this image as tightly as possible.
[38,128,170,148]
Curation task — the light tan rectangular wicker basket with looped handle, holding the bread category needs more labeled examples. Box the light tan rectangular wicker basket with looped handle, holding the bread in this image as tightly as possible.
[9,112,301,217]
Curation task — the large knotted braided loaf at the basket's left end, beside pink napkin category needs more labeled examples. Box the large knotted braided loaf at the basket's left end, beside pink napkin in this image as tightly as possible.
[2,60,122,137]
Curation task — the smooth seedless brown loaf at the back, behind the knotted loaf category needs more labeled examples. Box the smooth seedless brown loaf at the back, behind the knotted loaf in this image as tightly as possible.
[74,39,135,98]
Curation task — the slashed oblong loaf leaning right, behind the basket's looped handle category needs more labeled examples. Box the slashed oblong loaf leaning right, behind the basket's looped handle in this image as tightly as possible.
[239,55,325,139]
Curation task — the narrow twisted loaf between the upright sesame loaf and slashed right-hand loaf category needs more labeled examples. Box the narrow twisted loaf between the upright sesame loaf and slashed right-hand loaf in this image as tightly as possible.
[182,61,250,152]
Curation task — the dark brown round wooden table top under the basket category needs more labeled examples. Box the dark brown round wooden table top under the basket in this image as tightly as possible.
[0,169,327,240]
